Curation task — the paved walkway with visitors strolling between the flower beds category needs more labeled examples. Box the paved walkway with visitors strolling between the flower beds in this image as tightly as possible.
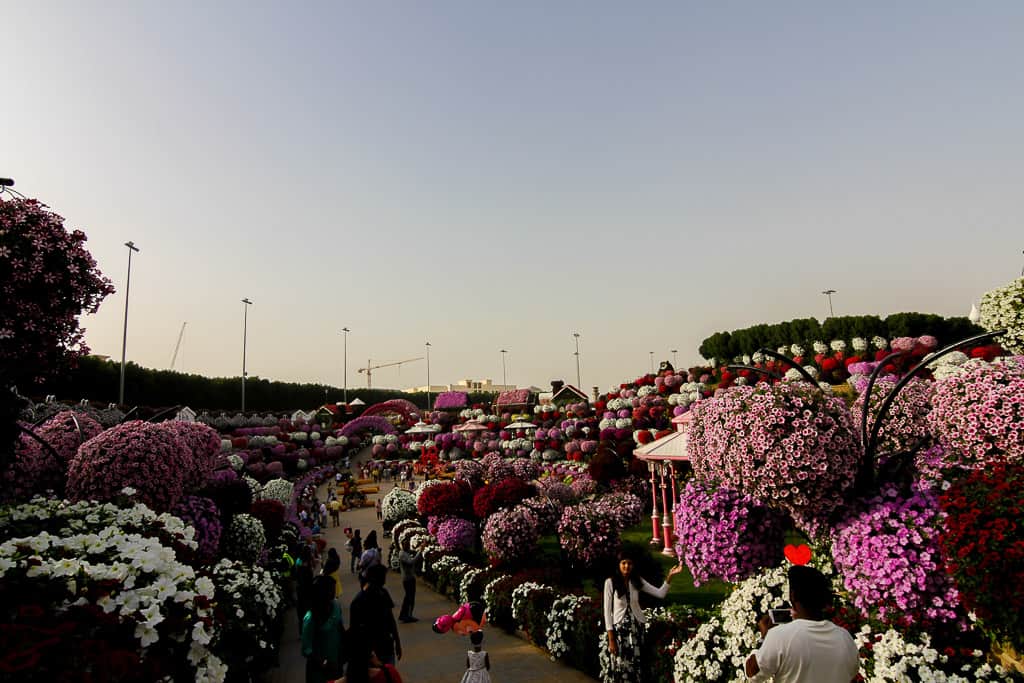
[268,454,594,683]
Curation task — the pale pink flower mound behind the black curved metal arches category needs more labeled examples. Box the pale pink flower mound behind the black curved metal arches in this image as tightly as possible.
[850,378,934,455]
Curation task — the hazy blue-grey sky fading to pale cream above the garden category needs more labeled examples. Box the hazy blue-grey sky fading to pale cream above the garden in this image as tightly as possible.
[0,0,1024,390]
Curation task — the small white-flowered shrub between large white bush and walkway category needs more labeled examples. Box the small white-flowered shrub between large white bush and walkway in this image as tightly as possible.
[210,559,285,672]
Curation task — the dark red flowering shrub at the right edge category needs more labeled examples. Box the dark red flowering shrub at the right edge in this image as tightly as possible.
[939,463,1024,651]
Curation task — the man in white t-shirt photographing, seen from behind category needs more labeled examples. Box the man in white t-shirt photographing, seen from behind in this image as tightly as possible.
[745,565,860,683]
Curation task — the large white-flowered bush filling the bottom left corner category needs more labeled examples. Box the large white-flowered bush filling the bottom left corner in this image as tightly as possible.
[0,499,226,681]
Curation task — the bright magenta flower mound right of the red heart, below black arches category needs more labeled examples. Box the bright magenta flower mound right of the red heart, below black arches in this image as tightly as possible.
[833,487,959,626]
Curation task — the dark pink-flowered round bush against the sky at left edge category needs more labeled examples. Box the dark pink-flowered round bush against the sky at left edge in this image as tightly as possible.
[0,200,114,389]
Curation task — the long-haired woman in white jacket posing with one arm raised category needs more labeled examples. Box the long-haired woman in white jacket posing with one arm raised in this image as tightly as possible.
[601,552,683,683]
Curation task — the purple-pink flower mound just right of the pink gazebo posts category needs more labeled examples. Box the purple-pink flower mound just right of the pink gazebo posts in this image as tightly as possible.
[675,480,785,586]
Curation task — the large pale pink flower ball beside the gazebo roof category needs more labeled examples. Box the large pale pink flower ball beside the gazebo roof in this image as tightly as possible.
[689,382,861,533]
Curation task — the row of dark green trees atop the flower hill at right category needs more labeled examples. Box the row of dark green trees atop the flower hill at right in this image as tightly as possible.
[698,313,984,360]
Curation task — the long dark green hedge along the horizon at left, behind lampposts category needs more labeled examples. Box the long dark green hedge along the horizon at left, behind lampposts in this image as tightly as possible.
[32,357,496,411]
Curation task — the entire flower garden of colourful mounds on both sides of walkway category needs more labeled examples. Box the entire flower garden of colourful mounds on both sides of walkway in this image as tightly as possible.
[0,194,1024,682]
